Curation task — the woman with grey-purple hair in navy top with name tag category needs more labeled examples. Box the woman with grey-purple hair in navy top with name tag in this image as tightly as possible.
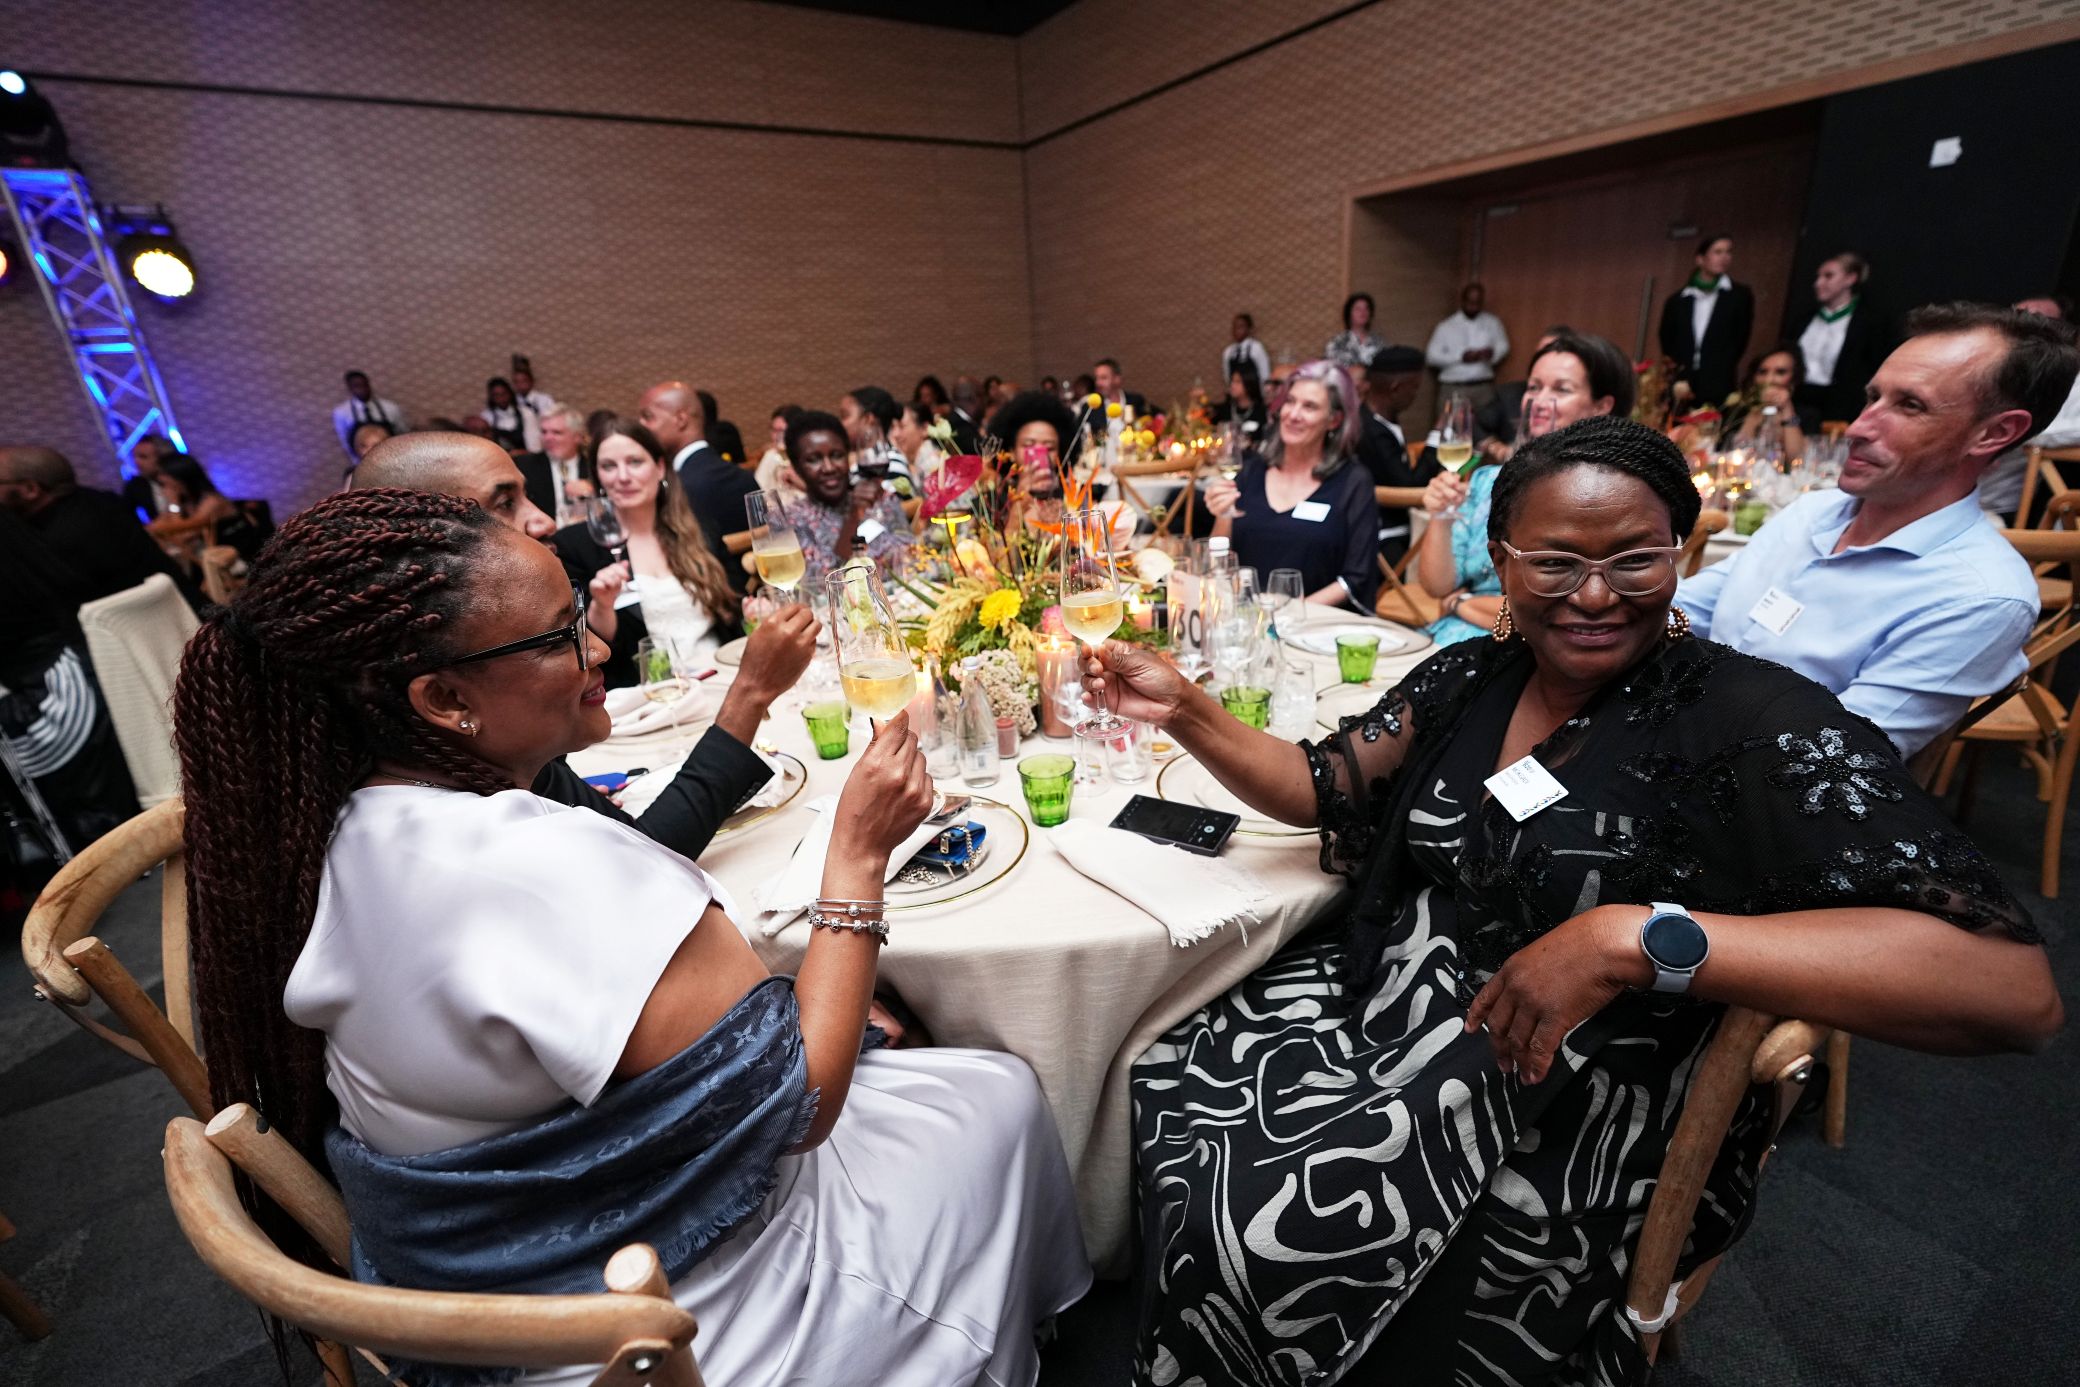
[1206,362,1379,611]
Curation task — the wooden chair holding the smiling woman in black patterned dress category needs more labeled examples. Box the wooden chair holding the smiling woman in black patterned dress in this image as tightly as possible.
[1624,1006,1828,1362]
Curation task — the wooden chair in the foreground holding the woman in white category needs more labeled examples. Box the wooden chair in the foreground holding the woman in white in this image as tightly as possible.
[164,1104,701,1387]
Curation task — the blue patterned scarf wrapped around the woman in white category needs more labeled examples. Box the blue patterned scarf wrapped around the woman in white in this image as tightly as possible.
[324,977,815,1387]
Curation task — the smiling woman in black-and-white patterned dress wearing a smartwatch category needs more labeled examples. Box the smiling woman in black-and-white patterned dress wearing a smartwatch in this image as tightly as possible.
[1088,418,2063,1385]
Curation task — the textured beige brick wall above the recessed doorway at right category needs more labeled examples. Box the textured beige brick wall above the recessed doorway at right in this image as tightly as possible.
[1019,0,2080,399]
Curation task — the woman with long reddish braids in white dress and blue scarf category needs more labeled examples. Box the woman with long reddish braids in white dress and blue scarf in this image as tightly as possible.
[175,489,1090,1385]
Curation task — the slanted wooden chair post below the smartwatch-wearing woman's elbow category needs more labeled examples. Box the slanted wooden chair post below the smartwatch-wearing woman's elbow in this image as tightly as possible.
[1624,1006,1772,1362]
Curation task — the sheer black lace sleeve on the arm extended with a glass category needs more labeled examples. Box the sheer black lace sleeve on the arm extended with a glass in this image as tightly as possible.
[1300,640,1489,875]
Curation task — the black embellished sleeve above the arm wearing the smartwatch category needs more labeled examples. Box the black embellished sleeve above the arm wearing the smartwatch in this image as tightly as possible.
[1618,643,2040,942]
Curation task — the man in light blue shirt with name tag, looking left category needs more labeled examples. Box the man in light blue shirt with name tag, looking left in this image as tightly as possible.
[1676,304,2080,757]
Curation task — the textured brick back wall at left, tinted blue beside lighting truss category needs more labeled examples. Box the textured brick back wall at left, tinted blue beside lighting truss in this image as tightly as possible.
[0,0,1032,507]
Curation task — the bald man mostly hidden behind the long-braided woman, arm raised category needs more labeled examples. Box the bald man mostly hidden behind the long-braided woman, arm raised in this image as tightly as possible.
[349,433,815,859]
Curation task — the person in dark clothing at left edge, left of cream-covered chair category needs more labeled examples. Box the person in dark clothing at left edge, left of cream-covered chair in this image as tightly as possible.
[0,445,198,605]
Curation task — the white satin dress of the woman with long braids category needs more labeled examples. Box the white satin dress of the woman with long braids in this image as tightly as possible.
[283,786,1090,1387]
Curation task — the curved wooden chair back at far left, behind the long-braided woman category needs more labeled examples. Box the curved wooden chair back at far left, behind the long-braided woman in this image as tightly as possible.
[21,799,216,1119]
